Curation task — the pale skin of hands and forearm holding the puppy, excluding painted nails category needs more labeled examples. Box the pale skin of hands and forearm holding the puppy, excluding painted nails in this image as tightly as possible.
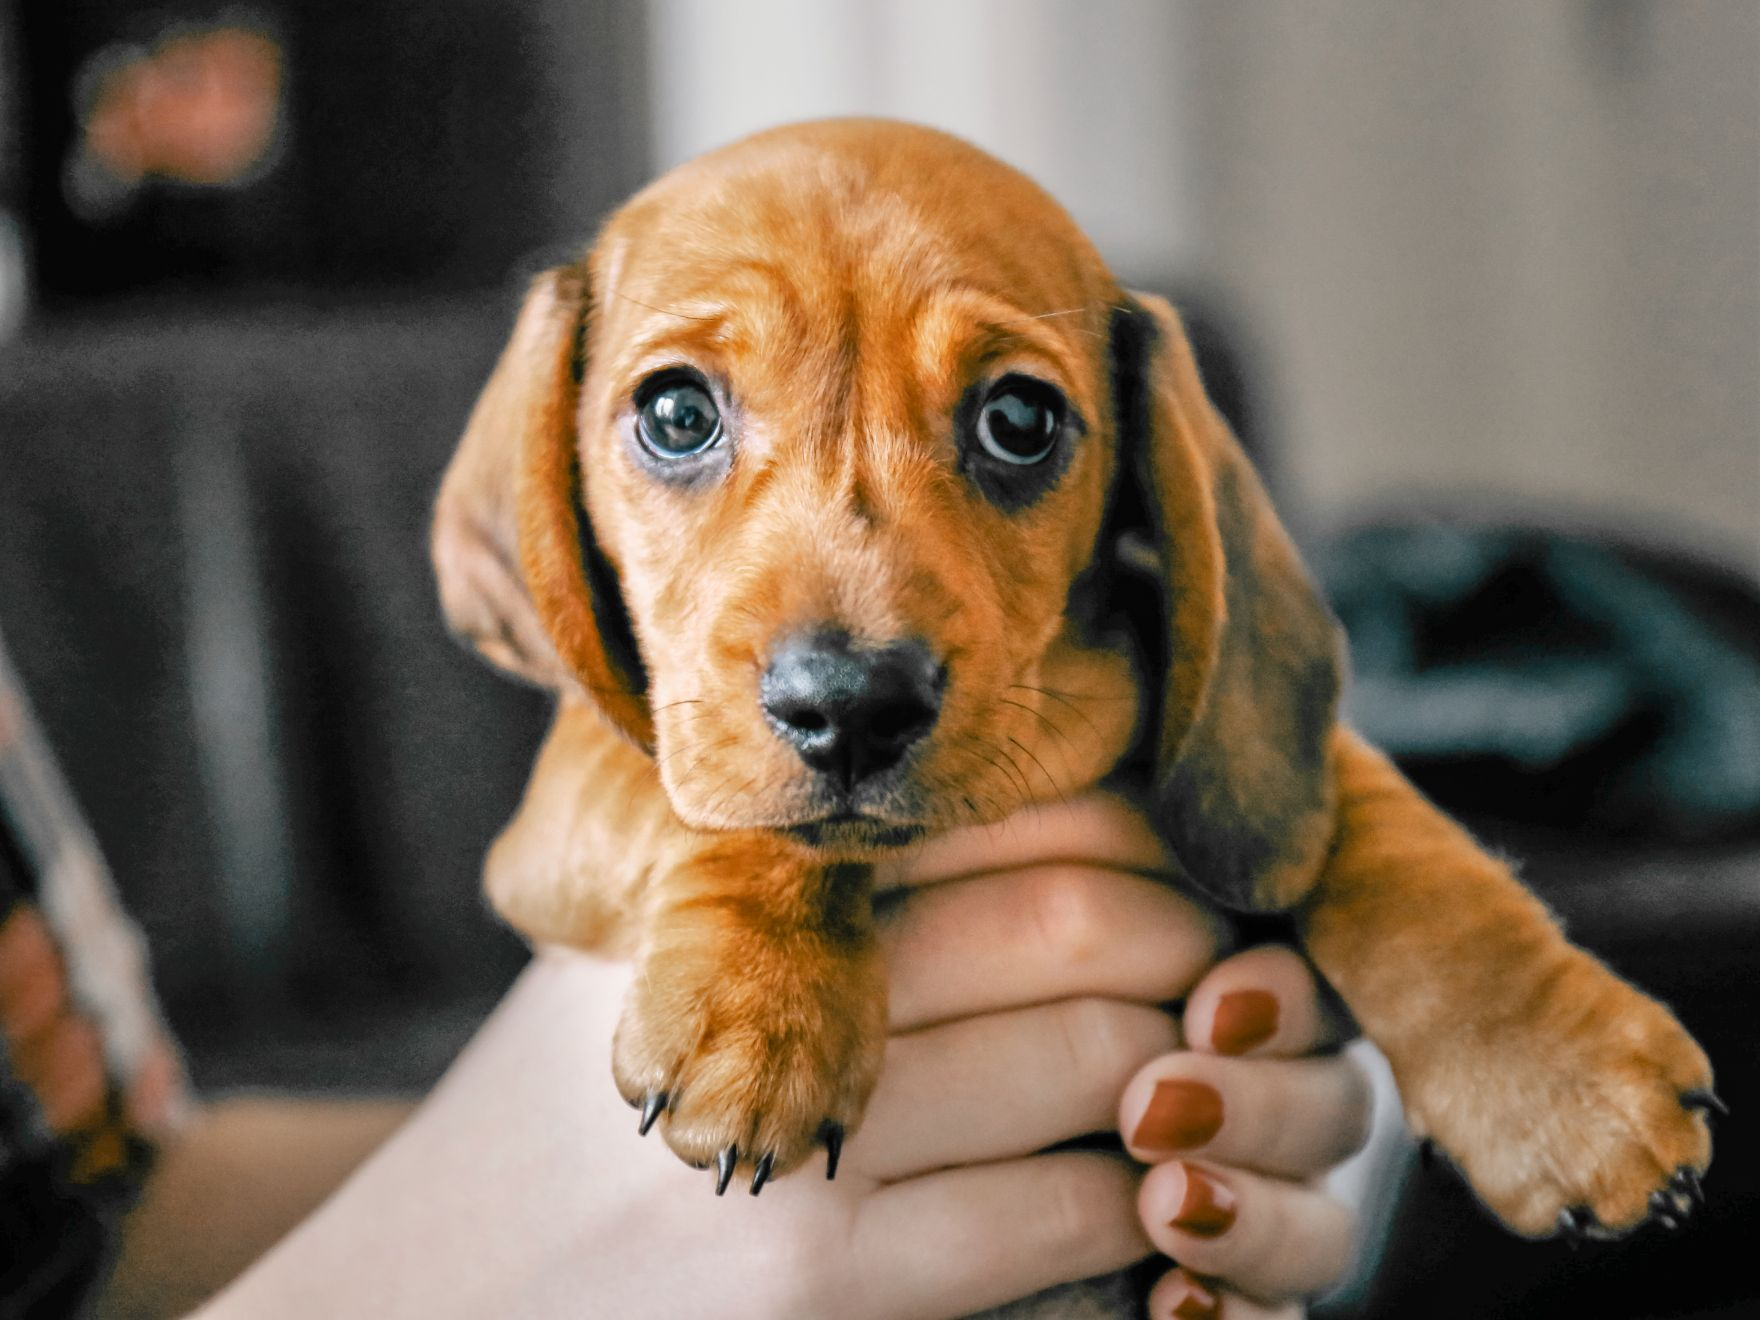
[202,796,1369,1320]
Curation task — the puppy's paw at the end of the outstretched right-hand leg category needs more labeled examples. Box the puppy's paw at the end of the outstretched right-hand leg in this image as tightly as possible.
[1394,950,1721,1237]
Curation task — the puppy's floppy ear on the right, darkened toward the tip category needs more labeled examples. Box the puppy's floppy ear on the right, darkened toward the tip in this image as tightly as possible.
[1112,296,1343,910]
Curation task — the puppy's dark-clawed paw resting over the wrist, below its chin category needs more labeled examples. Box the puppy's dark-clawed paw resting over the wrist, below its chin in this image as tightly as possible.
[612,943,885,1195]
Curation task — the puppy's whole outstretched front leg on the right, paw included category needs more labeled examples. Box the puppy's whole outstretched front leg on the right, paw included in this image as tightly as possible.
[1306,730,1711,1236]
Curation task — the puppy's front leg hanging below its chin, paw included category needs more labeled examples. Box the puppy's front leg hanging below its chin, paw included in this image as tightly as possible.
[612,834,885,1192]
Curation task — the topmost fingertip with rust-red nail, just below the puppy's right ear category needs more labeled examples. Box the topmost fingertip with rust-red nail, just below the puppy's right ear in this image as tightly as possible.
[1184,945,1353,1058]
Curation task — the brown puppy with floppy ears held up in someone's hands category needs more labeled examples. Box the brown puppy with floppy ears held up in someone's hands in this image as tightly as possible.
[435,121,1714,1234]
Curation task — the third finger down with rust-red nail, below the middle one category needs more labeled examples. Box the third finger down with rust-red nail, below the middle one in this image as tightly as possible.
[1137,1160,1353,1302]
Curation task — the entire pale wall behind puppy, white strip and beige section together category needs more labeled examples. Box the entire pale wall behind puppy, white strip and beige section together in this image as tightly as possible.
[649,0,1760,570]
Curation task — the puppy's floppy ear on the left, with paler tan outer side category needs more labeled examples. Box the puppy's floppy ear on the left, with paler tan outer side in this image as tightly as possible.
[433,268,653,748]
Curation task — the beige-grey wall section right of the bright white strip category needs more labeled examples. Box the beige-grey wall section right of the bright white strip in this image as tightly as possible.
[1192,0,1760,570]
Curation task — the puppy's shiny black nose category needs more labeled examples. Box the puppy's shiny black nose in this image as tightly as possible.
[759,632,945,792]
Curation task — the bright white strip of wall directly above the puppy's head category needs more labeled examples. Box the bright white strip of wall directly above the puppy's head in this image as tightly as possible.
[649,0,1193,279]
